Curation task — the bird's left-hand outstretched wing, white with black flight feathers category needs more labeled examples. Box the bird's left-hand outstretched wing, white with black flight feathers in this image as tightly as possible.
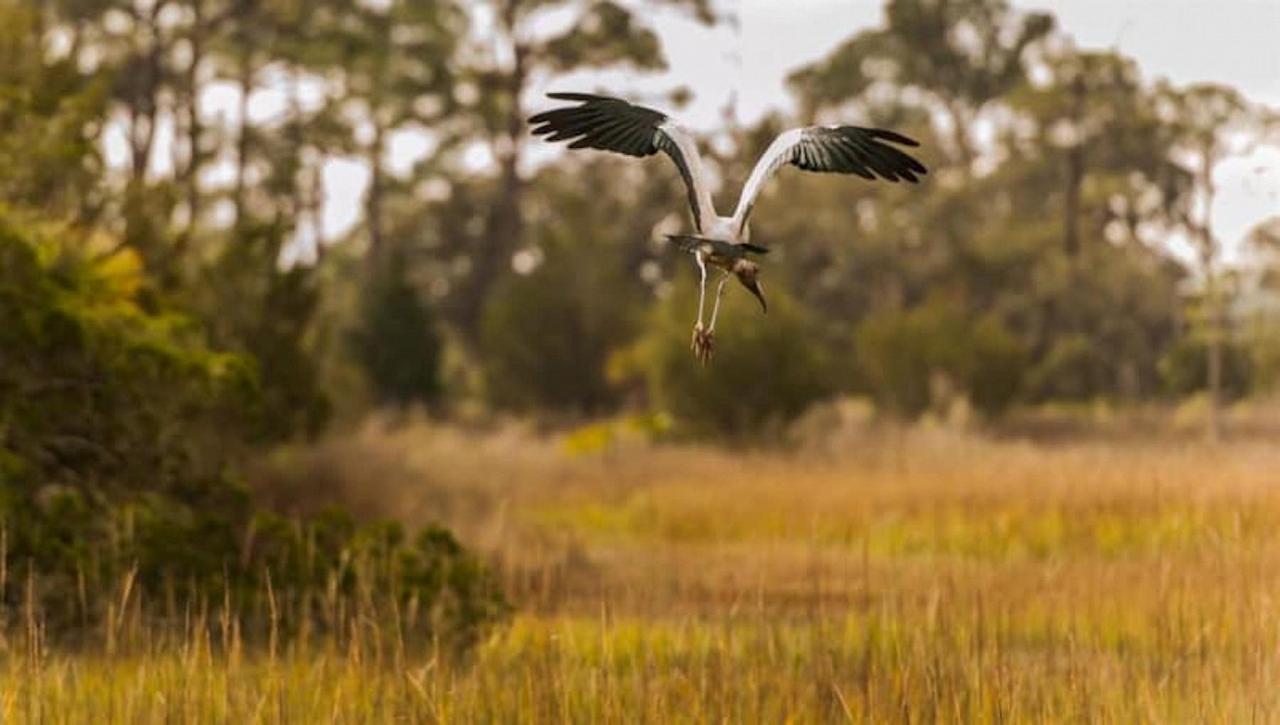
[529,94,716,232]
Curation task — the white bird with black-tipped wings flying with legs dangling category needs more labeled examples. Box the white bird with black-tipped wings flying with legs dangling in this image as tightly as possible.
[529,94,928,365]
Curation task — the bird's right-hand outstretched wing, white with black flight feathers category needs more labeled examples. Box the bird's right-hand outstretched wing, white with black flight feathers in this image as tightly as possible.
[733,126,928,233]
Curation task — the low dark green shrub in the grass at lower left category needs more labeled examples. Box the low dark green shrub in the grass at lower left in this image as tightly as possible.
[0,496,509,648]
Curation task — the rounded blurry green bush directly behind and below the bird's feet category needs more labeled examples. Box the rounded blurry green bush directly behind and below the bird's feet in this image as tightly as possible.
[640,274,838,439]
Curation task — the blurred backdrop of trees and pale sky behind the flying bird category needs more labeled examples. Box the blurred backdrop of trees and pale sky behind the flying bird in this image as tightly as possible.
[3,0,1280,443]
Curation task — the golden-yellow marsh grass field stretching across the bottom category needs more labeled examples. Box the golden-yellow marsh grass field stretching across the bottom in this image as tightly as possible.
[0,425,1280,722]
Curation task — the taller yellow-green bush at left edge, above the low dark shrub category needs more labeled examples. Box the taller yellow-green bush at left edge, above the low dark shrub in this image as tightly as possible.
[0,211,256,497]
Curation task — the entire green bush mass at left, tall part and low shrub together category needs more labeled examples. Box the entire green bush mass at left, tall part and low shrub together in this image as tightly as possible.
[0,211,506,644]
